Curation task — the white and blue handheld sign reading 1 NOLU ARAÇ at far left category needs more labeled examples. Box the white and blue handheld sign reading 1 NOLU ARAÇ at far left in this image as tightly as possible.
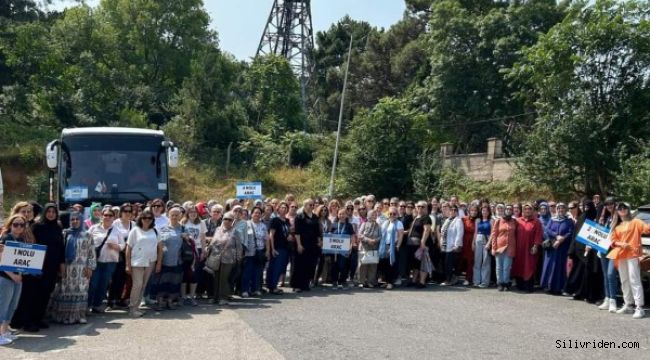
[0,241,47,275]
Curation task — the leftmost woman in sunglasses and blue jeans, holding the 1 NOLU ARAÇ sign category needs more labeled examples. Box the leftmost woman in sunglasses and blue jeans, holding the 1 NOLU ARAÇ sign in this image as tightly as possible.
[0,214,28,345]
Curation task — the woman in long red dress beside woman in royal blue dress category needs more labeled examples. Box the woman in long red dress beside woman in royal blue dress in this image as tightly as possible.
[512,203,544,293]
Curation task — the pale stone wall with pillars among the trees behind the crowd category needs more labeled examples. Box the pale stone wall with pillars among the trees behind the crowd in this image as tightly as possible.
[440,138,515,181]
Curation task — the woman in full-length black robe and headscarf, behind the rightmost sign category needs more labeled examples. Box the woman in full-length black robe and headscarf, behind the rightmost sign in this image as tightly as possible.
[564,199,605,303]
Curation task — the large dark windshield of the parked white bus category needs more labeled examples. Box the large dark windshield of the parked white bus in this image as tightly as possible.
[59,134,167,205]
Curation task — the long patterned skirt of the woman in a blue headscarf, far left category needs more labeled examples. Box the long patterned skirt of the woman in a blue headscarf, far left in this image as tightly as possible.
[49,264,90,324]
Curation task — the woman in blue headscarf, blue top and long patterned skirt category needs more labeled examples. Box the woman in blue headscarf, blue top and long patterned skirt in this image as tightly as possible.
[50,211,96,324]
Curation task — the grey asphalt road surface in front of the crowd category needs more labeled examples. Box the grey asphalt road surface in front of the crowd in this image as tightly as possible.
[0,287,650,360]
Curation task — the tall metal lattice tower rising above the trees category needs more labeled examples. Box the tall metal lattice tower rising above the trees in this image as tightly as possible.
[257,0,314,110]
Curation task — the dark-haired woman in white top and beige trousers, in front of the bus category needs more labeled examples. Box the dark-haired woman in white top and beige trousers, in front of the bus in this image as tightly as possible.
[126,209,162,318]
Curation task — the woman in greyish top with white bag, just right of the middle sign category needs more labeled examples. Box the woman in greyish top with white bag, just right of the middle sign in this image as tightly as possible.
[359,210,381,287]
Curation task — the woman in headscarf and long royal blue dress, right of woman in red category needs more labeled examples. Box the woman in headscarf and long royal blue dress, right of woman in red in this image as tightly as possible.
[541,203,575,295]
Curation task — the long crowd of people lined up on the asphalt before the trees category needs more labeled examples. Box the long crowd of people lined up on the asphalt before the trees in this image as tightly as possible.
[0,195,650,345]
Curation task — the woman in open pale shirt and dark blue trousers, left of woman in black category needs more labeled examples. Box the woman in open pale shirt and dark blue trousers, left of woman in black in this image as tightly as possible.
[241,207,269,298]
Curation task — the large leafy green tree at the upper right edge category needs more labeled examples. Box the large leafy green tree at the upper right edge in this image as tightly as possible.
[509,0,650,194]
